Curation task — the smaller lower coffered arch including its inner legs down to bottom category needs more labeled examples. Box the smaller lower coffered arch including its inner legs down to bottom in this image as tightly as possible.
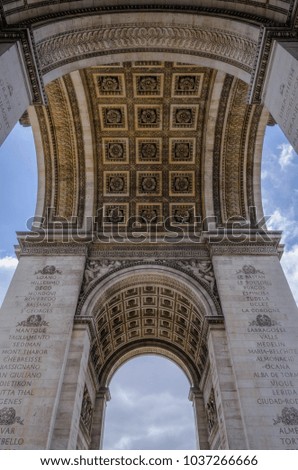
[76,262,223,448]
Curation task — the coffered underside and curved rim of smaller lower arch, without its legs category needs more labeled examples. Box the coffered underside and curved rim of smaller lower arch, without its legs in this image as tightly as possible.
[76,266,222,387]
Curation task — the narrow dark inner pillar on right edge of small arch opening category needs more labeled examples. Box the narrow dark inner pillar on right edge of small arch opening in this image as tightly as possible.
[189,387,210,450]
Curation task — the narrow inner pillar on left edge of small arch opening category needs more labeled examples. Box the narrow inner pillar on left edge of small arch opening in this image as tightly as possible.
[90,387,111,449]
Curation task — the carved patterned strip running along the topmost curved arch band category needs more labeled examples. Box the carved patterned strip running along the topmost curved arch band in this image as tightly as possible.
[37,23,257,74]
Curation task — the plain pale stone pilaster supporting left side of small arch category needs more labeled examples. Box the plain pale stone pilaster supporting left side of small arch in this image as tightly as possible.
[51,324,90,450]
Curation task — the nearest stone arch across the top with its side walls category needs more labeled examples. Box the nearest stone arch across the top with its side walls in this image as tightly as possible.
[0,6,297,151]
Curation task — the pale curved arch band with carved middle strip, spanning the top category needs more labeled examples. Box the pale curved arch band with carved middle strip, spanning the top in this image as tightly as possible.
[33,11,259,84]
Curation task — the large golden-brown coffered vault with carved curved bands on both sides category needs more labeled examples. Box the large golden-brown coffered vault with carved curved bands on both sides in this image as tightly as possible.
[31,61,268,231]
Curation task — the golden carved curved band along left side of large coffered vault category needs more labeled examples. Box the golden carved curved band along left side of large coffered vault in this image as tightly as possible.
[45,75,85,225]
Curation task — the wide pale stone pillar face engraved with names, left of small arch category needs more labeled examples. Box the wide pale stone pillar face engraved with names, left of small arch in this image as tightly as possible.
[0,244,85,449]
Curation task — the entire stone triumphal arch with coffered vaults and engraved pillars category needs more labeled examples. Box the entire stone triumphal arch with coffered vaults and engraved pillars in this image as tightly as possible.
[0,0,298,449]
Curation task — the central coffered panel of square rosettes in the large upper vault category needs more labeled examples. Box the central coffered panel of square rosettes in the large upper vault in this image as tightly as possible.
[83,62,212,231]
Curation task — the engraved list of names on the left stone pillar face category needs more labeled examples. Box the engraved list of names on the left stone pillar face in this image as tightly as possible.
[0,265,62,449]
